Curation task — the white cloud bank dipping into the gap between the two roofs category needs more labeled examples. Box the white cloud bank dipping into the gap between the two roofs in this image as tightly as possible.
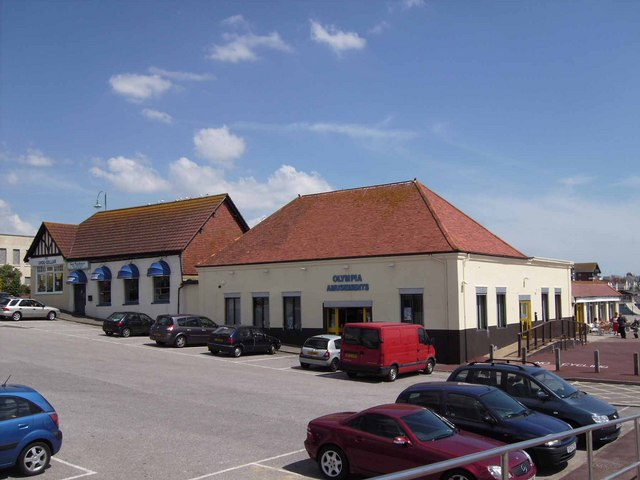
[169,157,331,215]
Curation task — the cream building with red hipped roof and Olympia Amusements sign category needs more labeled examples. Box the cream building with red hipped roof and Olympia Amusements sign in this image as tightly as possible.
[198,181,572,363]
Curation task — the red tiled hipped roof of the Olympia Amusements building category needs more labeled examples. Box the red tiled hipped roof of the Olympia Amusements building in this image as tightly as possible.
[200,181,527,266]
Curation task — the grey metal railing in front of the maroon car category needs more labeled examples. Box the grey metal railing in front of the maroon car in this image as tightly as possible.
[373,413,640,480]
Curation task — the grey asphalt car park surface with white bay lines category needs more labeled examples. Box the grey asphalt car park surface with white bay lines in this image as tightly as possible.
[0,320,640,480]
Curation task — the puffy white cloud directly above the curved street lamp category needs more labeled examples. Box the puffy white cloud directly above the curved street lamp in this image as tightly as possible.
[91,156,169,193]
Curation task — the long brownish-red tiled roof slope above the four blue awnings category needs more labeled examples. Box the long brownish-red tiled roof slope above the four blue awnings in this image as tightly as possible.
[68,194,239,259]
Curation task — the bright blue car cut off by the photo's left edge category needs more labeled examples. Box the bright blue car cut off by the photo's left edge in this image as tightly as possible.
[0,382,62,476]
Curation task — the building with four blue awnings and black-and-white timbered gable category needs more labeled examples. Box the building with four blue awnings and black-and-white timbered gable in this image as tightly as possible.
[25,194,249,318]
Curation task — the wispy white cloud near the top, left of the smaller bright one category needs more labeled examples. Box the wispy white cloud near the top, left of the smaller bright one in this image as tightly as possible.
[209,32,292,63]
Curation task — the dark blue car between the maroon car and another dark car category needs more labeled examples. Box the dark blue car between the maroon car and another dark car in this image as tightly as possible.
[396,382,576,467]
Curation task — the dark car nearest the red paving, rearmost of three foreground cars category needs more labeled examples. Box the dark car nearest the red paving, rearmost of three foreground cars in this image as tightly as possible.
[448,362,620,443]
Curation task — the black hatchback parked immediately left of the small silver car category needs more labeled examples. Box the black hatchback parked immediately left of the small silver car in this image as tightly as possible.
[207,325,280,357]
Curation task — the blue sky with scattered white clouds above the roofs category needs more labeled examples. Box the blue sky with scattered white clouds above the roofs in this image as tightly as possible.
[0,0,640,274]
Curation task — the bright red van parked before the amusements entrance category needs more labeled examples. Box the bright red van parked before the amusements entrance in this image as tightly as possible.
[340,322,436,382]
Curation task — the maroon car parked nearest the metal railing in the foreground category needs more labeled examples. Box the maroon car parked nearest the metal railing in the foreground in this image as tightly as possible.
[304,404,537,480]
